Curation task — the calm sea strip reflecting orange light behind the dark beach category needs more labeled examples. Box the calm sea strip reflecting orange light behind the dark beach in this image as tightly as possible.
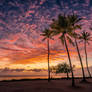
[0,73,82,81]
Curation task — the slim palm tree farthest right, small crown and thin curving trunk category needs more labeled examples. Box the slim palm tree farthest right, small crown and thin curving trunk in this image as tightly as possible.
[79,31,92,77]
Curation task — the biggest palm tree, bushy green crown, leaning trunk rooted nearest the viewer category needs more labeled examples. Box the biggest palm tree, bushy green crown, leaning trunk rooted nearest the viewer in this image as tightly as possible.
[51,14,75,86]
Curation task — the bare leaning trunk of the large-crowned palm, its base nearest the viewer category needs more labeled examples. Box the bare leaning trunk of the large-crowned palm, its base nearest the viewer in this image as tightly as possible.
[64,36,75,86]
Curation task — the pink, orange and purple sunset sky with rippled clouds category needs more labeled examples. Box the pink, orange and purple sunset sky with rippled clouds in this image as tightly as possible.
[0,0,92,75]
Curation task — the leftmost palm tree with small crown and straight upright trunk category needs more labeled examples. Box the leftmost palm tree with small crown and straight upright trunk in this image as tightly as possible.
[41,29,52,82]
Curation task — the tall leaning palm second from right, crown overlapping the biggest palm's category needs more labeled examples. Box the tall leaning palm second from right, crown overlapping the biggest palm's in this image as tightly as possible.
[68,14,86,82]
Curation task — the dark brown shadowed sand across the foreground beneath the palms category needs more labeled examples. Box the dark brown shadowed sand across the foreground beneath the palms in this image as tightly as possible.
[0,79,92,92]
